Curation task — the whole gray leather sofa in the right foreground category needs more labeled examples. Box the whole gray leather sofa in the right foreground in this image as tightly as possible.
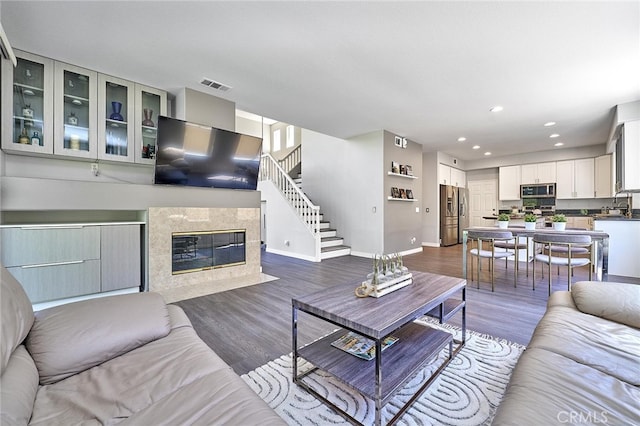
[493,281,640,426]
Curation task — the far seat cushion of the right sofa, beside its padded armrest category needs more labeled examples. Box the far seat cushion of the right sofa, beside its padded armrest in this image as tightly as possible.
[527,302,640,386]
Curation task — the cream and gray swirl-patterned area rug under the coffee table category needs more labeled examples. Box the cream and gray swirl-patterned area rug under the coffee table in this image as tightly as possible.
[242,317,525,426]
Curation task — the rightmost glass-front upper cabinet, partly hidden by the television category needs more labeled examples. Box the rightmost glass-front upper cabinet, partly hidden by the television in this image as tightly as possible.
[135,84,167,164]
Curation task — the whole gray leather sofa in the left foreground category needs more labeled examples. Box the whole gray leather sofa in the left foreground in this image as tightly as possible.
[0,265,285,425]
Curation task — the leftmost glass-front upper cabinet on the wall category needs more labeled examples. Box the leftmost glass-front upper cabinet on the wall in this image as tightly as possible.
[2,51,53,154]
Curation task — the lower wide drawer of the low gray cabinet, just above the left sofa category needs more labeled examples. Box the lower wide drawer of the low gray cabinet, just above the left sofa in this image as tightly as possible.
[7,260,100,303]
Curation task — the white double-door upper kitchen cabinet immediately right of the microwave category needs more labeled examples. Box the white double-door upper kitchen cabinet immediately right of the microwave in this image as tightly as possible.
[556,158,594,200]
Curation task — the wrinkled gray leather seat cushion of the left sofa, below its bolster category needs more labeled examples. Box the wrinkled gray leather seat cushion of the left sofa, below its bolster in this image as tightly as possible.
[31,307,277,425]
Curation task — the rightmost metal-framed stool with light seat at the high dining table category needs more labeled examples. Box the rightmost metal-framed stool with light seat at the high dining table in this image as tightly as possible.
[533,234,592,295]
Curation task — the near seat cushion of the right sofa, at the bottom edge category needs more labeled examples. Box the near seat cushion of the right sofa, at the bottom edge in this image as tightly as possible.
[492,348,640,426]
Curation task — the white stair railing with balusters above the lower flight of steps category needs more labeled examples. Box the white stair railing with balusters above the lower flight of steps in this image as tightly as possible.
[260,154,320,238]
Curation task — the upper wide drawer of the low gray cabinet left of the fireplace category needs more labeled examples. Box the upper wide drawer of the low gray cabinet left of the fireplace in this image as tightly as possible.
[2,226,100,268]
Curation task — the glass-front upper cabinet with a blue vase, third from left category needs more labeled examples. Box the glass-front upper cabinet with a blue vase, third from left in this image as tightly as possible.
[98,74,135,163]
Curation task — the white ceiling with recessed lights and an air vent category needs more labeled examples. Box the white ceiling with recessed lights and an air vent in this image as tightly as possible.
[0,0,640,160]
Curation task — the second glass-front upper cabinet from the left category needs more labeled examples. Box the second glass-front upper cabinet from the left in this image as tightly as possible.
[53,62,98,158]
